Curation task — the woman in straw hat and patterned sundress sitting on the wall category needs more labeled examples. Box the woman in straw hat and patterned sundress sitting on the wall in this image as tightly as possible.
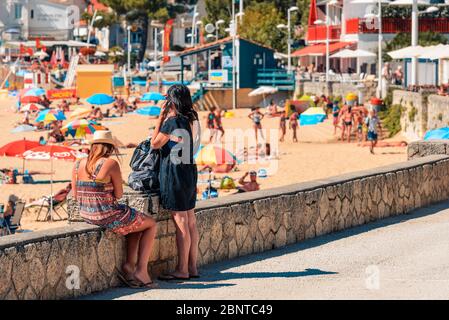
[72,130,156,288]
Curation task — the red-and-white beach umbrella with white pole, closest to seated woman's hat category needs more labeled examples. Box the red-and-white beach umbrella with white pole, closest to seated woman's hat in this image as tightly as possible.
[23,145,87,220]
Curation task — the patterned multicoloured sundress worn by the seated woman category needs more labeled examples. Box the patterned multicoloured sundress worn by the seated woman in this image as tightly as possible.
[75,159,144,236]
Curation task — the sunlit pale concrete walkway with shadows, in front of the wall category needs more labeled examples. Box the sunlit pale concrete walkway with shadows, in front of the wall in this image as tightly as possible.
[85,202,449,300]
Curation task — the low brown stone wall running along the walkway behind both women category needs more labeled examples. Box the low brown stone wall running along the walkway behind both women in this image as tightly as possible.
[0,155,449,299]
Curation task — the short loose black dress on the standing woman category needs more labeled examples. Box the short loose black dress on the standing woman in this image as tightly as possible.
[159,115,198,211]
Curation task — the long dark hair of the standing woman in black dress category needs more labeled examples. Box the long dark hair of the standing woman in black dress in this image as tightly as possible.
[167,84,198,123]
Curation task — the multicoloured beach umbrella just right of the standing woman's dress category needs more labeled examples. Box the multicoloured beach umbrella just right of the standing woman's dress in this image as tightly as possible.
[195,144,238,173]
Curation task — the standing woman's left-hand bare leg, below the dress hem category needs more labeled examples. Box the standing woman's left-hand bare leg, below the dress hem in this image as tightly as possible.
[172,211,191,279]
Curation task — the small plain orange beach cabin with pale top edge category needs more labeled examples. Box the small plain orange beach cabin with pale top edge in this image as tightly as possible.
[76,64,114,99]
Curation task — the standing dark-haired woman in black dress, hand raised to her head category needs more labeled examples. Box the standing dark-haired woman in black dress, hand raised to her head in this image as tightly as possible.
[151,85,199,280]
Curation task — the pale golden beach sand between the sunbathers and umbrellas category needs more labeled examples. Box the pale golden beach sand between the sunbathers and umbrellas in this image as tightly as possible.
[0,95,407,231]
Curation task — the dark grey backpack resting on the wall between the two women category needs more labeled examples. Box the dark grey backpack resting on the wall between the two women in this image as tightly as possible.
[128,139,161,194]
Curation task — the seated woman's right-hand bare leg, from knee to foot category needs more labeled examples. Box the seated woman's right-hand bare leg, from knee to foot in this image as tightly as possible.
[130,218,157,284]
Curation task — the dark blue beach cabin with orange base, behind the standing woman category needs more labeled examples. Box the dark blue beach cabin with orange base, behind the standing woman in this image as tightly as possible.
[178,37,295,109]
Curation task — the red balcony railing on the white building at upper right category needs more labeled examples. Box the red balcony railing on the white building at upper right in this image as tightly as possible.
[346,18,449,34]
